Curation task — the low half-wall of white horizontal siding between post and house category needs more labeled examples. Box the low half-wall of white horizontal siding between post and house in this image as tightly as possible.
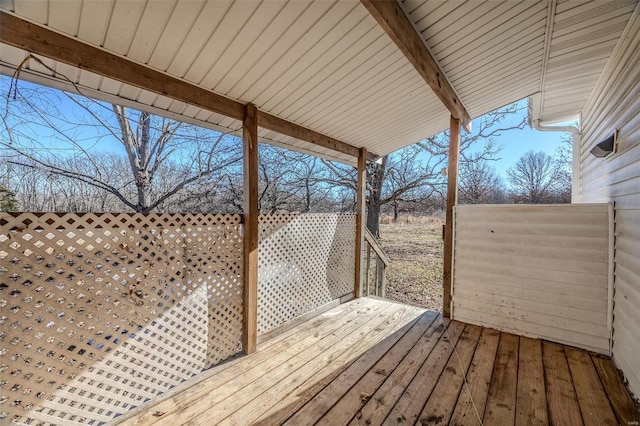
[452,204,610,353]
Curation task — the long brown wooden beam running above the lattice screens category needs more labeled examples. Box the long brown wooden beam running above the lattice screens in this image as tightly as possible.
[0,11,375,160]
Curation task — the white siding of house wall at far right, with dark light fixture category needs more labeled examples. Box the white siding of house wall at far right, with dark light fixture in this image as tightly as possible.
[580,4,640,395]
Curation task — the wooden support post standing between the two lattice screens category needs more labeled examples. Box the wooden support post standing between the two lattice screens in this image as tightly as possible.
[242,104,259,354]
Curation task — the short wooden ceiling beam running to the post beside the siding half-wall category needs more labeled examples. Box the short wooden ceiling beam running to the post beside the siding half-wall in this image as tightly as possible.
[360,0,471,132]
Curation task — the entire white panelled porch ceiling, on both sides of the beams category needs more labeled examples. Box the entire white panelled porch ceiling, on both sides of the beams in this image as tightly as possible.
[0,0,638,163]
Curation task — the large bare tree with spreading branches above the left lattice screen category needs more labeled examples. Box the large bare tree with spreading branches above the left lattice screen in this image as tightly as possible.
[0,77,242,213]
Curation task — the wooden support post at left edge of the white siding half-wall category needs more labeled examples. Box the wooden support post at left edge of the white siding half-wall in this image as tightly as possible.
[442,115,460,318]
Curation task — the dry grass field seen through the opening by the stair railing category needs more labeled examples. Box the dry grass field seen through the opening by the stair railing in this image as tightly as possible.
[380,216,444,311]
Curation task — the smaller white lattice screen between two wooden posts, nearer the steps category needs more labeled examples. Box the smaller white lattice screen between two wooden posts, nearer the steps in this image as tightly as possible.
[258,214,356,333]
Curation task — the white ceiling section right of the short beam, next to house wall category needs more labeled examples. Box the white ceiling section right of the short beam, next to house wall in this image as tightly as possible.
[401,0,638,123]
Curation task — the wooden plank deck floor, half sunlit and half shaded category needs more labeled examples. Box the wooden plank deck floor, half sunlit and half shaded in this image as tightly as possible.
[116,298,640,426]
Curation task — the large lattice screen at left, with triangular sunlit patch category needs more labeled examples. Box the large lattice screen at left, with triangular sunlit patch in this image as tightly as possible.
[0,213,242,425]
